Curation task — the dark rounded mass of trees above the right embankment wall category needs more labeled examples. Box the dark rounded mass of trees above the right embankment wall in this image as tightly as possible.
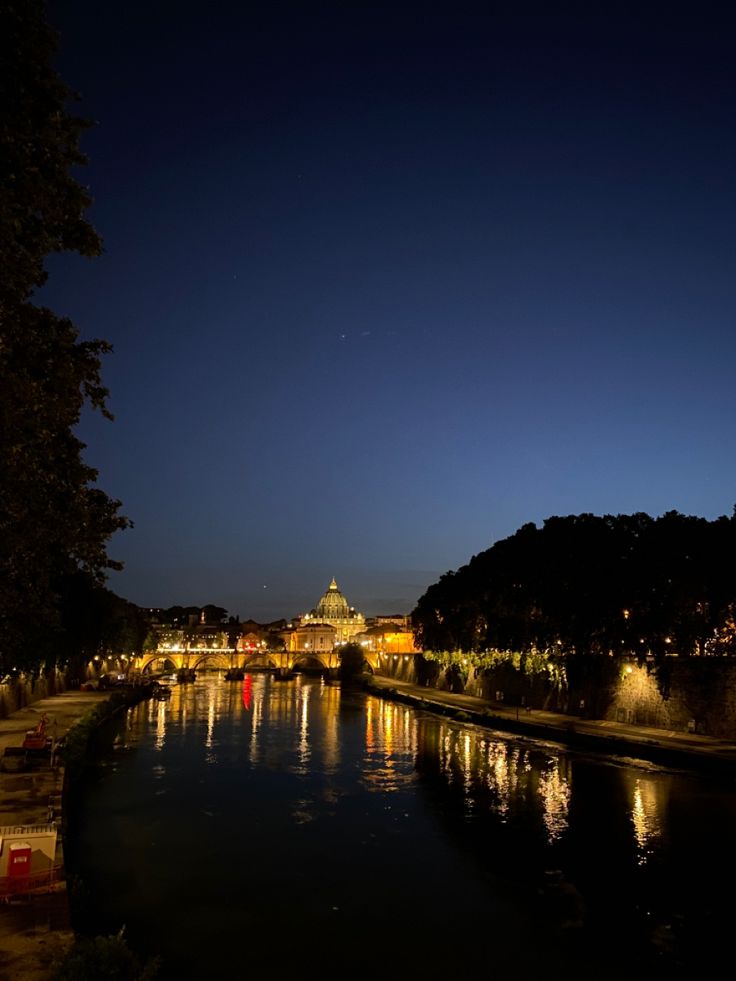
[413,511,736,659]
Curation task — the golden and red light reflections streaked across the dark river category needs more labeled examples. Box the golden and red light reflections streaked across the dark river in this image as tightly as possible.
[128,675,667,865]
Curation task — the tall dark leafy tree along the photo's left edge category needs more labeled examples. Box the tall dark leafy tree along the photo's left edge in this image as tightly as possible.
[0,0,129,676]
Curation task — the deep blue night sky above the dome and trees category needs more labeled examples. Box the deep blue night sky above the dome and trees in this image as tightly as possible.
[40,0,736,621]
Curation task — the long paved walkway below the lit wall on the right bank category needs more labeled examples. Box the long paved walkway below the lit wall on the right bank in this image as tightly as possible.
[366,675,736,777]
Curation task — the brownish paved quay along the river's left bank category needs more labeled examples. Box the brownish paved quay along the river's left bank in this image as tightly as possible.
[0,691,150,981]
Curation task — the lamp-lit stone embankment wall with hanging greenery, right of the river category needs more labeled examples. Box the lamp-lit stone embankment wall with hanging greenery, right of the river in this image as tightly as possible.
[382,654,736,739]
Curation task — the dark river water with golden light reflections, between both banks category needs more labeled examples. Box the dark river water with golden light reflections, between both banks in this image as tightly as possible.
[65,674,736,981]
